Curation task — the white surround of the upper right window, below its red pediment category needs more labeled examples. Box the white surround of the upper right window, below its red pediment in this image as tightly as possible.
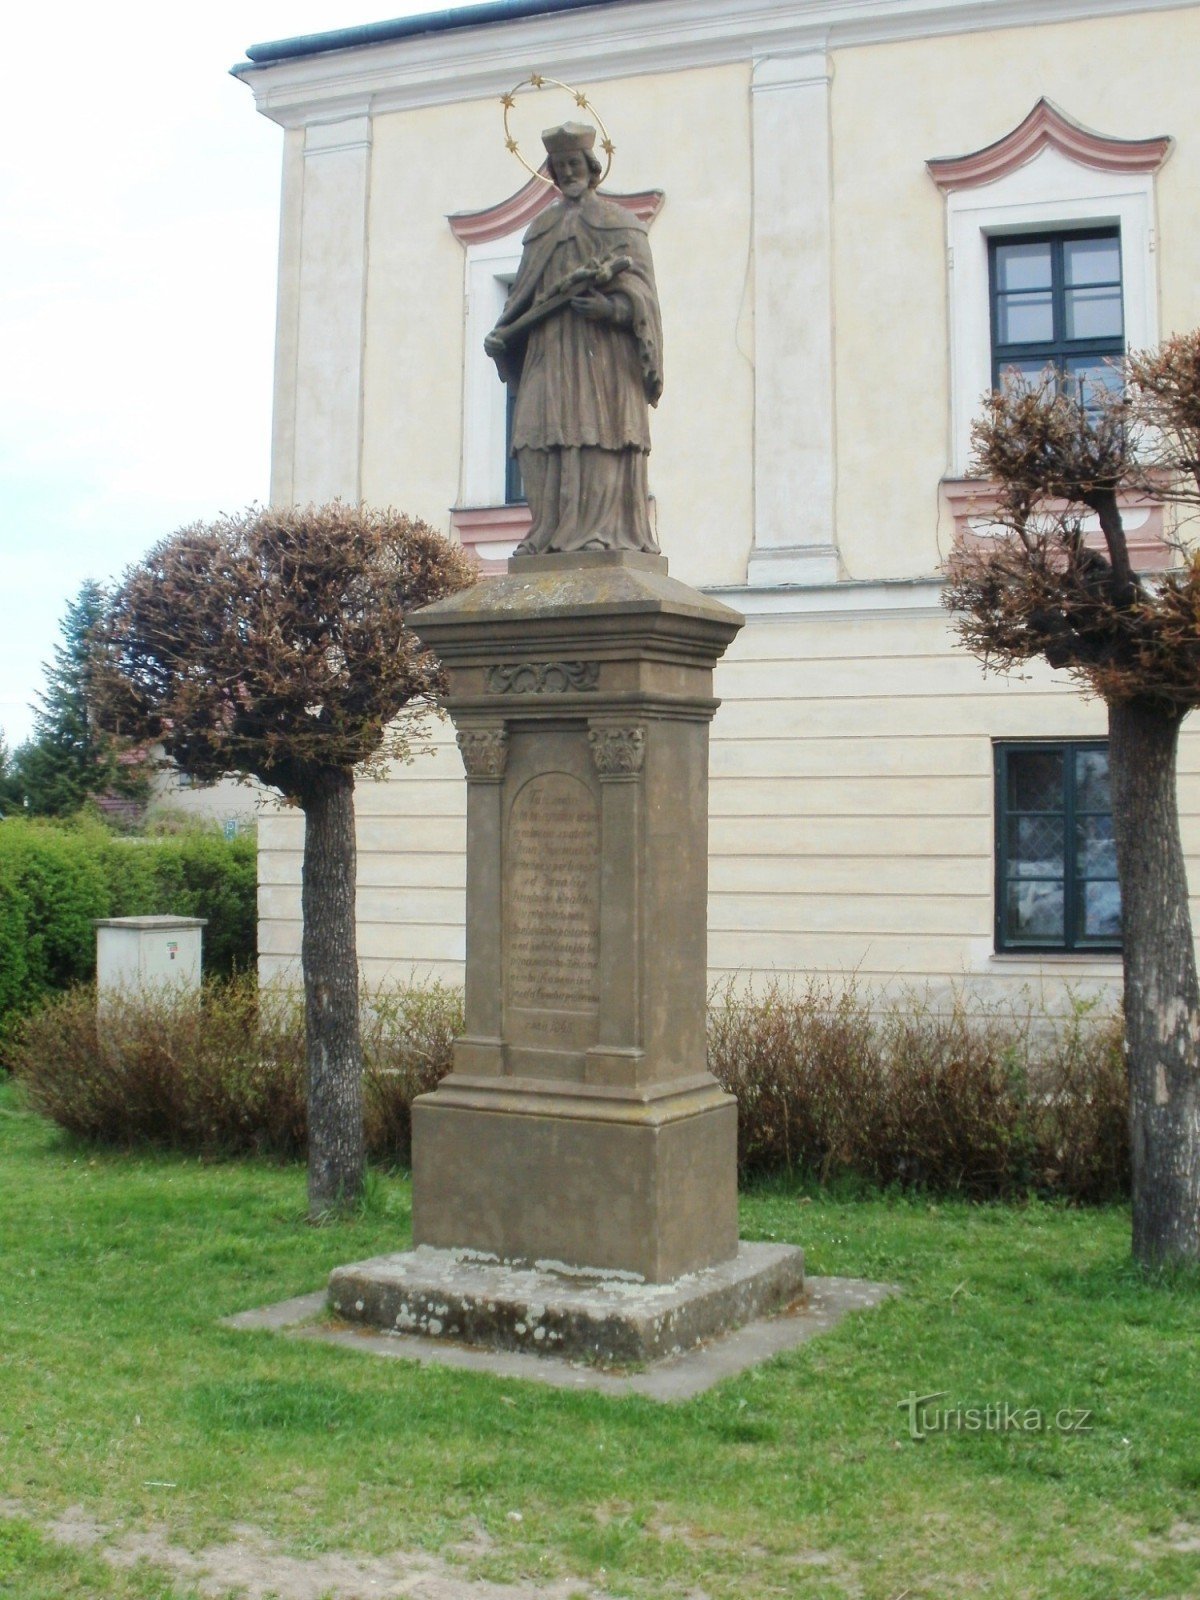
[946,146,1158,478]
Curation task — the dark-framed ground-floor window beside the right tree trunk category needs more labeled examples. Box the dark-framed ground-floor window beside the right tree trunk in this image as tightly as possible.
[995,741,1122,950]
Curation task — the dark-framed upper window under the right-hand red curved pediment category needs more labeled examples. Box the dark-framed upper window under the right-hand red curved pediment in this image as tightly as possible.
[987,227,1125,398]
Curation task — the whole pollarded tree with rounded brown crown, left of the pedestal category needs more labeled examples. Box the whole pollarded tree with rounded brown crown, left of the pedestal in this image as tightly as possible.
[93,502,474,1216]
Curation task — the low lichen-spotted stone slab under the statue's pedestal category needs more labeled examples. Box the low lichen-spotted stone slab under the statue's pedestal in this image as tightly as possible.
[330,1243,805,1366]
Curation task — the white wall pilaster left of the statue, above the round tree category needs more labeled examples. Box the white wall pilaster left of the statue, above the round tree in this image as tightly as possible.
[291,112,371,504]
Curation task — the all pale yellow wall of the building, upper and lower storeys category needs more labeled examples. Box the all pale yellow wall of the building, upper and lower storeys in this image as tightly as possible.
[261,8,1200,989]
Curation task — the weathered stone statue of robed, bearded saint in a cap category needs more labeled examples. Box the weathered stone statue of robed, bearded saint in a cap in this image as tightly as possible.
[483,122,662,555]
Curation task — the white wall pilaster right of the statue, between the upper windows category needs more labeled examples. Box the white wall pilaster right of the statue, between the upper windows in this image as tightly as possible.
[747,51,838,584]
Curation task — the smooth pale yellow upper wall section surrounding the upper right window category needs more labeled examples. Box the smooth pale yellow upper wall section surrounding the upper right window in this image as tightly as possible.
[832,11,1200,578]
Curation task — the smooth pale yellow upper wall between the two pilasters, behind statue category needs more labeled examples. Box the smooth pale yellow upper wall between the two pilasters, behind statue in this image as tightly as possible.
[363,66,754,582]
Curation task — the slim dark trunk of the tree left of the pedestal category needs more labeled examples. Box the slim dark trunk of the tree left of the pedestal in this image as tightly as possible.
[301,770,365,1218]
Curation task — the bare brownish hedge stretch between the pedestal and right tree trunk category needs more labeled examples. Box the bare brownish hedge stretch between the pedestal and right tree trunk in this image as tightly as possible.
[709,979,1128,1200]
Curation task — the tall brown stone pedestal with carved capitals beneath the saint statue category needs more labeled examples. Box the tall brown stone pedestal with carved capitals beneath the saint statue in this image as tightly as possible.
[400,550,742,1283]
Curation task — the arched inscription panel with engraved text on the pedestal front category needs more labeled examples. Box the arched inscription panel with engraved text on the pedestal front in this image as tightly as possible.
[504,773,600,1050]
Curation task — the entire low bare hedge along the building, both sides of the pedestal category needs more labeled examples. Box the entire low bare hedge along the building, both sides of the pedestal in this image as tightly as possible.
[10,978,1130,1202]
